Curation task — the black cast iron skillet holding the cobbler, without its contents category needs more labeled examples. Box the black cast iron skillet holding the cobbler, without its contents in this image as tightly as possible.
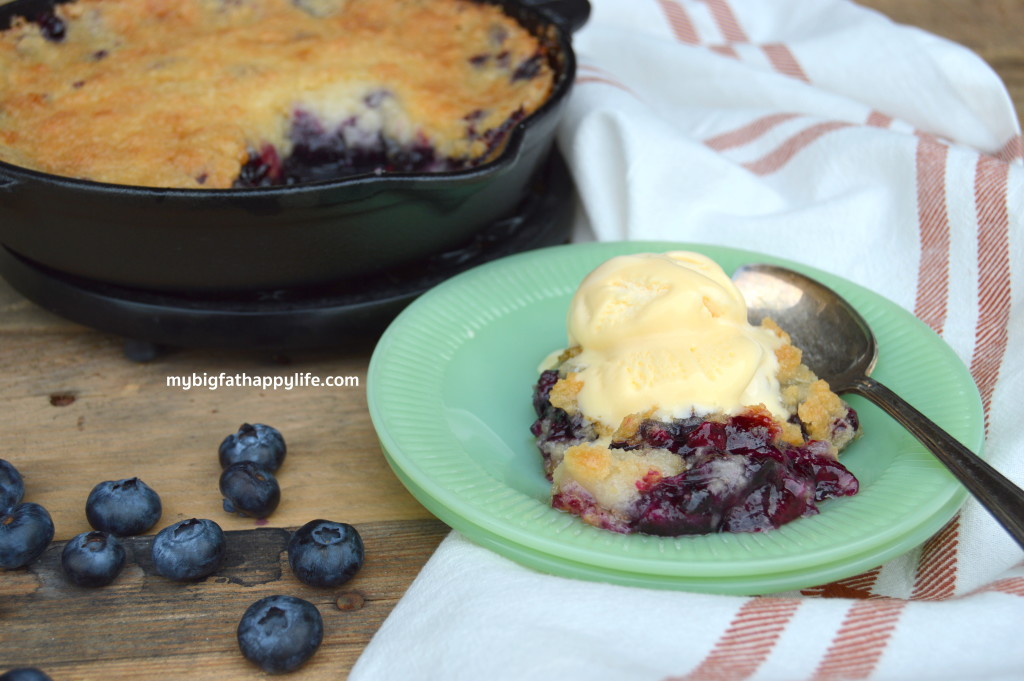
[0,0,590,293]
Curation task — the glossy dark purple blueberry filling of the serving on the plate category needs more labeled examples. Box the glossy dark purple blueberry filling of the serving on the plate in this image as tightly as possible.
[530,371,859,537]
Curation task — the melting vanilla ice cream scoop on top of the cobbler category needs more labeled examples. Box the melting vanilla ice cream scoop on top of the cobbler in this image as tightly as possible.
[564,251,788,426]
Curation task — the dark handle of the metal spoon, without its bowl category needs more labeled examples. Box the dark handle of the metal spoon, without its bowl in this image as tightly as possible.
[846,376,1024,548]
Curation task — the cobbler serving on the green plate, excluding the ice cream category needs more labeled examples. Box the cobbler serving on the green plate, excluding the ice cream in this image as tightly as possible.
[532,320,860,535]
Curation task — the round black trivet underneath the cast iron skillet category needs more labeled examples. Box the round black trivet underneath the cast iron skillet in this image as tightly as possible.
[0,151,575,352]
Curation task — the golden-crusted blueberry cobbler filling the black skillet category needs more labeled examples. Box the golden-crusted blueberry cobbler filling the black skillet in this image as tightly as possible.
[0,0,554,188]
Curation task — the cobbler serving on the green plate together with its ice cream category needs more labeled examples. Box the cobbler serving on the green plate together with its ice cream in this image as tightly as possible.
[531,251,860,536]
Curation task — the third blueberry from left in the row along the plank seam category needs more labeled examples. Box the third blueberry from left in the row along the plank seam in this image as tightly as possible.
[152,518,227,582]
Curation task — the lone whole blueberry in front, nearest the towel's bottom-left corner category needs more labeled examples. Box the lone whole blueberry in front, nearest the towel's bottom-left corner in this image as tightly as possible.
[238,596,324,674]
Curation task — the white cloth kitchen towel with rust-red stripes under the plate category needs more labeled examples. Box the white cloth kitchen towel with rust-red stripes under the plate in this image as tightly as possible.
[350,0,1024,681]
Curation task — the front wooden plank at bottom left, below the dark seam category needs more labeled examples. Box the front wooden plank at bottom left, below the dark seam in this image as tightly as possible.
[0,520,447,681]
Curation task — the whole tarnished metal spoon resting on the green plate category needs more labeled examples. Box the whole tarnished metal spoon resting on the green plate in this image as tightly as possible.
[732,264,1024,547]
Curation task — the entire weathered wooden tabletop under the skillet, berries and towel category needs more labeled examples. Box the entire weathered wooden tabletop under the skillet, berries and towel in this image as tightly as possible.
[0,0,1024,681]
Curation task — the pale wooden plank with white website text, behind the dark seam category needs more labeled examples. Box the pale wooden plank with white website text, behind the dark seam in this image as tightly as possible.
[0,329,431,539]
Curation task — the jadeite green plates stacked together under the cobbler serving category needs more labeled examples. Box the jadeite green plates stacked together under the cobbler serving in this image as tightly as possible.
[368,242,983,594]
